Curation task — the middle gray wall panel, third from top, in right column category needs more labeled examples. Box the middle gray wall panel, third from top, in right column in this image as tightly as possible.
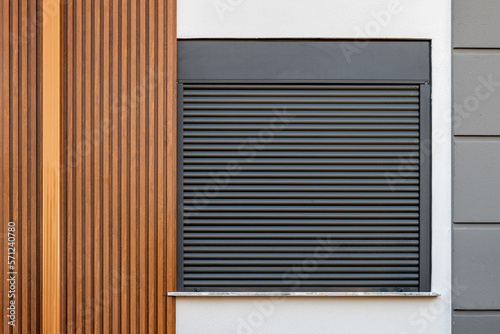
[453,138,500,223]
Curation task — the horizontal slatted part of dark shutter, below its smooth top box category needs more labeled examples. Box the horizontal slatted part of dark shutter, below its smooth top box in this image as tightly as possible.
[178,83,421,292]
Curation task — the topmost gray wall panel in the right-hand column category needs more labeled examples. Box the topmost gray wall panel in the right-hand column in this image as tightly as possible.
[453,0,500,47]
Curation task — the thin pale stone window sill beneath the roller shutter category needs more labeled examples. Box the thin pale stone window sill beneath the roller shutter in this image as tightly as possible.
[168,292,441,297]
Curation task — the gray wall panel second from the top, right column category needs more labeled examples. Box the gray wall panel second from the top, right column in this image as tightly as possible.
[453,52,500,135]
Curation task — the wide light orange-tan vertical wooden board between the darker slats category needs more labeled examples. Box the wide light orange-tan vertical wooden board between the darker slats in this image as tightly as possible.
[42,0,61,333]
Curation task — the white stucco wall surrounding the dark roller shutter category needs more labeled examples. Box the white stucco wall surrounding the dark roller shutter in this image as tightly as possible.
[176,0,451,334]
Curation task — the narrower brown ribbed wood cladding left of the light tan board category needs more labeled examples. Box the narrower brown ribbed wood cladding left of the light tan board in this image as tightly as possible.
[0,0,42,333]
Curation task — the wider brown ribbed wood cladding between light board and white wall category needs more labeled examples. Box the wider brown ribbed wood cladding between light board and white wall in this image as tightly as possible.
[61,0,175,333]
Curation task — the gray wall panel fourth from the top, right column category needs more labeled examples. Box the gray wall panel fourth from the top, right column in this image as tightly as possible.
[453,224,500,310]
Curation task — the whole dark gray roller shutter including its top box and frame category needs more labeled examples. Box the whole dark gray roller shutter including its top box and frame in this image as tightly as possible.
[177,40,431,292]
